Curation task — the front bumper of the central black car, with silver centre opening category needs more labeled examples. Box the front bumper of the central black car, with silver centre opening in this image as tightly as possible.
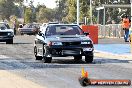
[47,45,94,56]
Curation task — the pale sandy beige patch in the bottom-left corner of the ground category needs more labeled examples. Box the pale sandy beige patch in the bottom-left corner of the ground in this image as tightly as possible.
[0,70,46,88]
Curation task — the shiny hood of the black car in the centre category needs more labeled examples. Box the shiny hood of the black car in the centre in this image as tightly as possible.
[47,35,91,42]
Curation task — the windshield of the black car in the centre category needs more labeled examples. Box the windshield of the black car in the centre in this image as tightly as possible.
[46,25,83,36]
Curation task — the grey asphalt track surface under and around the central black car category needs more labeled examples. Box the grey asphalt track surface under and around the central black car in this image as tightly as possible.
[0,35,132,88]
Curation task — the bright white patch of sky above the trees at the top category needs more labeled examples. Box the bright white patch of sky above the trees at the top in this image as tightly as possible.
[25,0,56,8]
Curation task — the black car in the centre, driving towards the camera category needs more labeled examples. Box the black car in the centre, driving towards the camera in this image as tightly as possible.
[34,24,94,63]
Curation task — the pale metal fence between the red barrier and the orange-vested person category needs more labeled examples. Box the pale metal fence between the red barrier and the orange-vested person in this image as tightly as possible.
[98,24,123,38]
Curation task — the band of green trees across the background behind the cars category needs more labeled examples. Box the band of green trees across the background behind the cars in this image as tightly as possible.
[0,0,131,24]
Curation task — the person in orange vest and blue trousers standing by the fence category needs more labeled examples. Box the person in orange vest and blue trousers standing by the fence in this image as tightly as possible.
[122,16,131,42]
